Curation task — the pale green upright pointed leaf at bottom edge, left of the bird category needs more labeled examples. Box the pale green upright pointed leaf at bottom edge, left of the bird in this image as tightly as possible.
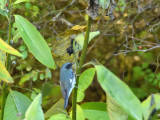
[25,94,44,120]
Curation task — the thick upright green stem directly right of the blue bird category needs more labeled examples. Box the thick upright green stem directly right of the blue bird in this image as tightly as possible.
[72,16,92,120]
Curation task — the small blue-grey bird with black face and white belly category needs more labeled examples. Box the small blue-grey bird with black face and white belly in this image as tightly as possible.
[60,62,76,109]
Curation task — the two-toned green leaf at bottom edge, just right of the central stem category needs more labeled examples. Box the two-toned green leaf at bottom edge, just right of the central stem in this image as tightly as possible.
[81,102,110,120]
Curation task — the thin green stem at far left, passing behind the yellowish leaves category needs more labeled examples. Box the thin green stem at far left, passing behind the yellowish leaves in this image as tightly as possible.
[1,0,12,120]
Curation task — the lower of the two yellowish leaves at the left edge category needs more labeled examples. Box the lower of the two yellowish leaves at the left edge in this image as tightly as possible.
[0,61,14,83]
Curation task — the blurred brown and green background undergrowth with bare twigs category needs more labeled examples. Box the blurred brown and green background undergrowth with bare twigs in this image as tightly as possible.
[0,0,160,118]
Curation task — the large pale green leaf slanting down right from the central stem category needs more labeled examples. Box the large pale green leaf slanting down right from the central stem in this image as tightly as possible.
[95,65,142,120]
